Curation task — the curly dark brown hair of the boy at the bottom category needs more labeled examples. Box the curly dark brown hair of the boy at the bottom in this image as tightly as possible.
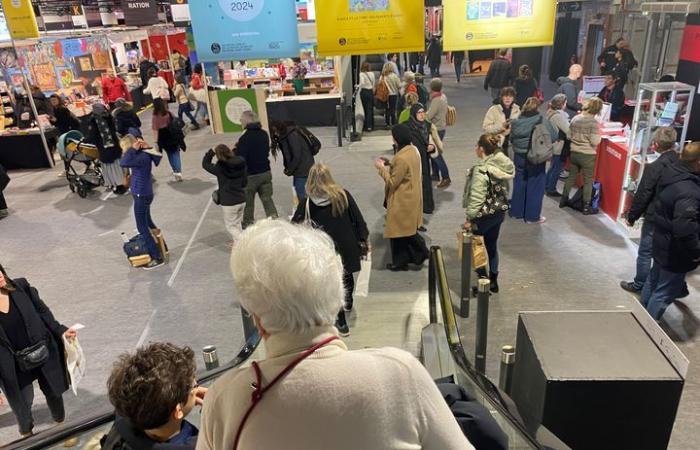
[107,342,196,430]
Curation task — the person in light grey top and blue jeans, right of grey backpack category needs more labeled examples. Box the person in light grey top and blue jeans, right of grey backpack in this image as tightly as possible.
[544,94,571,197]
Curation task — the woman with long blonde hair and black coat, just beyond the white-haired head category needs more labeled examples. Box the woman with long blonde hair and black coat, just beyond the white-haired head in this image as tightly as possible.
[292,163,369,336]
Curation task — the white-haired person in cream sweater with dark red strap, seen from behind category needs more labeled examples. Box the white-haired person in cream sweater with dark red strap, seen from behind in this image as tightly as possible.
[197,220,474,450]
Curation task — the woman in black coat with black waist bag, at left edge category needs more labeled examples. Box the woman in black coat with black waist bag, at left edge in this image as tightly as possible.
[0,265,77,436]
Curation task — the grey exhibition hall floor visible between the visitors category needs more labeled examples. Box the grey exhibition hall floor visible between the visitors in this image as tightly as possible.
[0,66,700,450]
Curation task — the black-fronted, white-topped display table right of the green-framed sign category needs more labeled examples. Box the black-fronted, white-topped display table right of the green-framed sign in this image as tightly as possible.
[265,94,342,127]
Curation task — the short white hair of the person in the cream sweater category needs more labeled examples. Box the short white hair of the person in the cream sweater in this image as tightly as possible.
[231,219,344,334]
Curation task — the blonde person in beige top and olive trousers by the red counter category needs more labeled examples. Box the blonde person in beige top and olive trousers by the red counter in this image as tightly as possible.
[559,97,603,215]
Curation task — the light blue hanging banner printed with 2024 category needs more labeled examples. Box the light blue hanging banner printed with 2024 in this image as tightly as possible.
[190,0,299,62]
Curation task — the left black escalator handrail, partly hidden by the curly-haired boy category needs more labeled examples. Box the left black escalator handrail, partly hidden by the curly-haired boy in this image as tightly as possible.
[8,329,260,450]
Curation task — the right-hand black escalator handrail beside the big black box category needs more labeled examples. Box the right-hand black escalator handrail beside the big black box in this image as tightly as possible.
[428,246,546,450]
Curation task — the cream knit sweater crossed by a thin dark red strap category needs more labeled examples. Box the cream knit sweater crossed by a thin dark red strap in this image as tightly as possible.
[197,327,474,450]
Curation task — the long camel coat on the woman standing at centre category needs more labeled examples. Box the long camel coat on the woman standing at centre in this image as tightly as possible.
[379,145,423,239]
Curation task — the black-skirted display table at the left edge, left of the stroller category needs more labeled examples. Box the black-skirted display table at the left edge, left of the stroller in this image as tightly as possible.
[0,128,58,170]
